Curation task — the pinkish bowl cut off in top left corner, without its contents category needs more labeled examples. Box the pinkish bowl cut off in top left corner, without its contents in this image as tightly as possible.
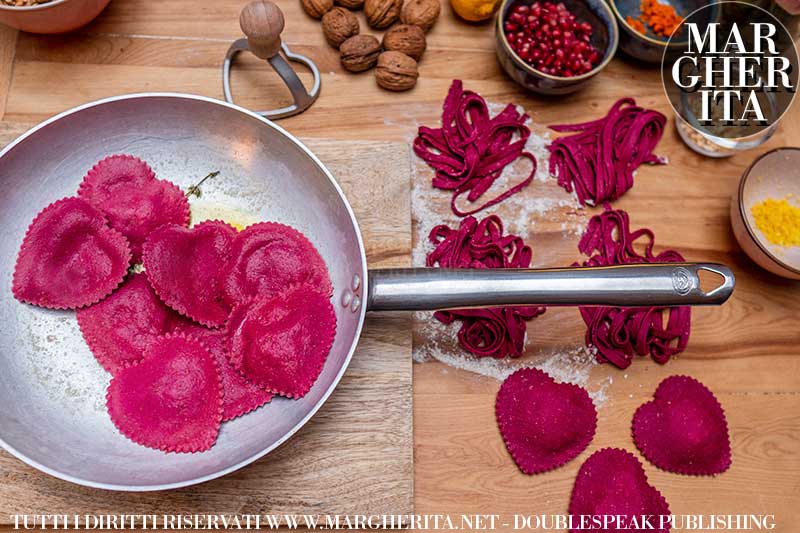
[0,0,111,33]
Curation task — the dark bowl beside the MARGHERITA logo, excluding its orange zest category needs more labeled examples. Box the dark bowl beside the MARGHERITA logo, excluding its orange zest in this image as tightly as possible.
[610,0,720,63]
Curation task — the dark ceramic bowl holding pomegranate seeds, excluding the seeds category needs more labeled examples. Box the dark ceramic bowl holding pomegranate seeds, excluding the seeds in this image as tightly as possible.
[495,0,619,94]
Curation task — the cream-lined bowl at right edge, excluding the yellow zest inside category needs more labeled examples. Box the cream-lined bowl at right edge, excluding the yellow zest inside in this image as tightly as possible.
[731,148,800,279]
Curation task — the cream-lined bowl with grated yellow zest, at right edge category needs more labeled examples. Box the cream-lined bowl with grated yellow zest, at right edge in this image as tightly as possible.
[731,148,800,279]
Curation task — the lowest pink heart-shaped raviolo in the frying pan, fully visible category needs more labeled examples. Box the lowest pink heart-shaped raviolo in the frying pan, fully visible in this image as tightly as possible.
[106,335,223,453]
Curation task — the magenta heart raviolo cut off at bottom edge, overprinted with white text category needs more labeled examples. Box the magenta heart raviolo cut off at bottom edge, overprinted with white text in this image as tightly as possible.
[569,448,670,533]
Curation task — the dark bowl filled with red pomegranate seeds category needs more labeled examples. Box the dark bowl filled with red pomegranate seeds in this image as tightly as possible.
[496,0,619,94]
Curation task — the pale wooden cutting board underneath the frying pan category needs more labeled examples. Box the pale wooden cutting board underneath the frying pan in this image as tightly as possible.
[0,122,413,525]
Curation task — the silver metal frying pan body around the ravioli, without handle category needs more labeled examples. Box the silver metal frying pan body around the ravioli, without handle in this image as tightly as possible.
[0,94,367,491]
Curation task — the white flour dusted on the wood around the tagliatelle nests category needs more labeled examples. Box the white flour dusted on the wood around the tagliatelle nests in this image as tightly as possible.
[411,98,611,407]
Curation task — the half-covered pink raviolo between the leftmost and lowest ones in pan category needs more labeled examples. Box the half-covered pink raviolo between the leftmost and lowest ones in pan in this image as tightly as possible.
[77,274,181,374]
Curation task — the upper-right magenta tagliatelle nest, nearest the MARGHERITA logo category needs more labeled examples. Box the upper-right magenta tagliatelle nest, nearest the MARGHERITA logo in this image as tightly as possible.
[548,98,667,205]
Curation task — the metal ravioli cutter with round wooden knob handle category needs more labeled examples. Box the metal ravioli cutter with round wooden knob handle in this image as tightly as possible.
[222,0,321,120]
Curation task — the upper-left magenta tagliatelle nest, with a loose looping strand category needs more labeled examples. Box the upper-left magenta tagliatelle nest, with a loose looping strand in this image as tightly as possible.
[414,80,536,216]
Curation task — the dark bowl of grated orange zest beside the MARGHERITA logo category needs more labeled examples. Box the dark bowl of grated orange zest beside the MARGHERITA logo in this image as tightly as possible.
[610,0,719,63]
